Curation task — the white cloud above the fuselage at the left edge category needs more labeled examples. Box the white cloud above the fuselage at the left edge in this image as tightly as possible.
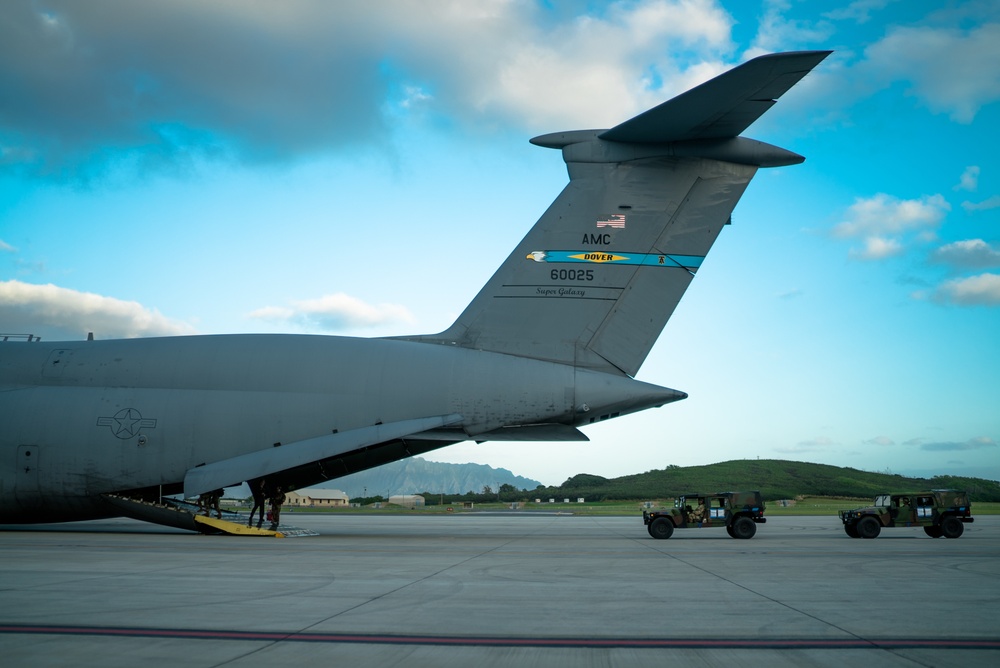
[0,281,195,339]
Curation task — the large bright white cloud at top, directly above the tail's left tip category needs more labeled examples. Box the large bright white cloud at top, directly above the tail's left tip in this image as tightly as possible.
[474,0,732,131]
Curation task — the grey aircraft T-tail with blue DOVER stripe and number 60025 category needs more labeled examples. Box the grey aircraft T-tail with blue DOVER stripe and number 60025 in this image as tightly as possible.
[398,51,829,376]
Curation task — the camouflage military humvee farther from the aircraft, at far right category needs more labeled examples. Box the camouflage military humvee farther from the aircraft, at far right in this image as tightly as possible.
[839,489,973,538]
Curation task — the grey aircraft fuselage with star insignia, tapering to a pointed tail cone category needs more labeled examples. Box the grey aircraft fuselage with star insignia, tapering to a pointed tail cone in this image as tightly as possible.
[0,335,684,522]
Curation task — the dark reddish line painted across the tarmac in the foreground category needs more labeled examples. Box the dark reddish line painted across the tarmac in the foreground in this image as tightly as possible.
[0,624,1000,650]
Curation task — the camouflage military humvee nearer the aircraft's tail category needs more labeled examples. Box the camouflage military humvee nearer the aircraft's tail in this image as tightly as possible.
[642,491,767,539]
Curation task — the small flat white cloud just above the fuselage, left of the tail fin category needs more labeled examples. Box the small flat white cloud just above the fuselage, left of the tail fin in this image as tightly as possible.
[249,292,415,332]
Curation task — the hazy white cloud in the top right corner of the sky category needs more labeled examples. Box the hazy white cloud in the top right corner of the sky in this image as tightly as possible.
[865,23,1000,123]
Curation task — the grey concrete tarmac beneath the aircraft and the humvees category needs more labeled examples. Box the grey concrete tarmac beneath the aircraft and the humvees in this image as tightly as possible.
[0,510,1000,668]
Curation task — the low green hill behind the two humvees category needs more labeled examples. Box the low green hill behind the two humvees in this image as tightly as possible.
[532,459,1000,501]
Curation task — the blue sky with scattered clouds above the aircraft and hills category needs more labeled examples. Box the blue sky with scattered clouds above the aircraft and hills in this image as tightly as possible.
[0,0,1000,484]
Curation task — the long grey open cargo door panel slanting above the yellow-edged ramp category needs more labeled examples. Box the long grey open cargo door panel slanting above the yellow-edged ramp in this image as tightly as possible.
[184,414,462,498]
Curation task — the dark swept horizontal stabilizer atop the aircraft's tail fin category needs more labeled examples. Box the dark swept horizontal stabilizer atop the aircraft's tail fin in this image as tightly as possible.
[598,51,833,144]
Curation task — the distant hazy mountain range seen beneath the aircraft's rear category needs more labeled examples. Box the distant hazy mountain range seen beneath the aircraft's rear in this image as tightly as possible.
[316,457,541,498]
